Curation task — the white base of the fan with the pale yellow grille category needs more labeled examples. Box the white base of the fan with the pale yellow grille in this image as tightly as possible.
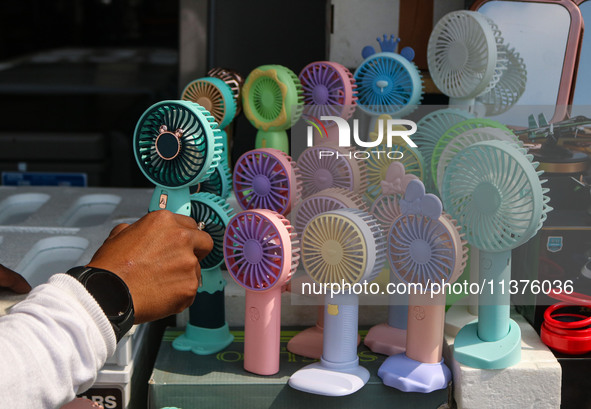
[289,360,369,396]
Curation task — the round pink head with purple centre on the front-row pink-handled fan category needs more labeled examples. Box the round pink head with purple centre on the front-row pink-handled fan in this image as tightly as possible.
[224,209,300,291]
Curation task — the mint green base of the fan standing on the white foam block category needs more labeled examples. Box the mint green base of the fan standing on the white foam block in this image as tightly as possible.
[454,320,521,369]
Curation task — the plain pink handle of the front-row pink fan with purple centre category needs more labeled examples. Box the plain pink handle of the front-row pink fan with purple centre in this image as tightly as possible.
[244,285,281,375]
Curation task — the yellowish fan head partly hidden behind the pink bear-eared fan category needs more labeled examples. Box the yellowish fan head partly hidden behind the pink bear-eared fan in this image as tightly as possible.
[365,143,424,202]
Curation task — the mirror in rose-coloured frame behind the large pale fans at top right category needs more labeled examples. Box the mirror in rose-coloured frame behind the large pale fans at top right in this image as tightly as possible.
[472,0,583,127]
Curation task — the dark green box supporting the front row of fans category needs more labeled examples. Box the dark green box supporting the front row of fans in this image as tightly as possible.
[149,328,451,409]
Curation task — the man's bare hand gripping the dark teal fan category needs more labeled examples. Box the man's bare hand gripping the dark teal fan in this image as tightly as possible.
[88,210,213,324]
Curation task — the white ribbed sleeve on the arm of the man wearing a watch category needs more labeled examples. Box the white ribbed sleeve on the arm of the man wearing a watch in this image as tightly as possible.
[0,274,116,409]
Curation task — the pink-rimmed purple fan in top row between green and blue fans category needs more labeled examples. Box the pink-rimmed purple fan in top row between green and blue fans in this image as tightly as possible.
[298,61,357,143]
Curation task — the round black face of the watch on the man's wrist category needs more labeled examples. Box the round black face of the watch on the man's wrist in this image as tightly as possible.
[86,271,131,321]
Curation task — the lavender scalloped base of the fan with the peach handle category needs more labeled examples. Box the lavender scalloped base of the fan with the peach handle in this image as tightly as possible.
[378,354,451,393]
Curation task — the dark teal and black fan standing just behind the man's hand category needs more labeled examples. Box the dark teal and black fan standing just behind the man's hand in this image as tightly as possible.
[172,193,234,355]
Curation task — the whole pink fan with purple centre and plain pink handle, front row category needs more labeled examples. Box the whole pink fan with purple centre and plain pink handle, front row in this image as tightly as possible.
[224,209,300,375]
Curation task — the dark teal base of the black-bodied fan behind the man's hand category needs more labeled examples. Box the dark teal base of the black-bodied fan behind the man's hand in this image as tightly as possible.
[172,322,234,355]
